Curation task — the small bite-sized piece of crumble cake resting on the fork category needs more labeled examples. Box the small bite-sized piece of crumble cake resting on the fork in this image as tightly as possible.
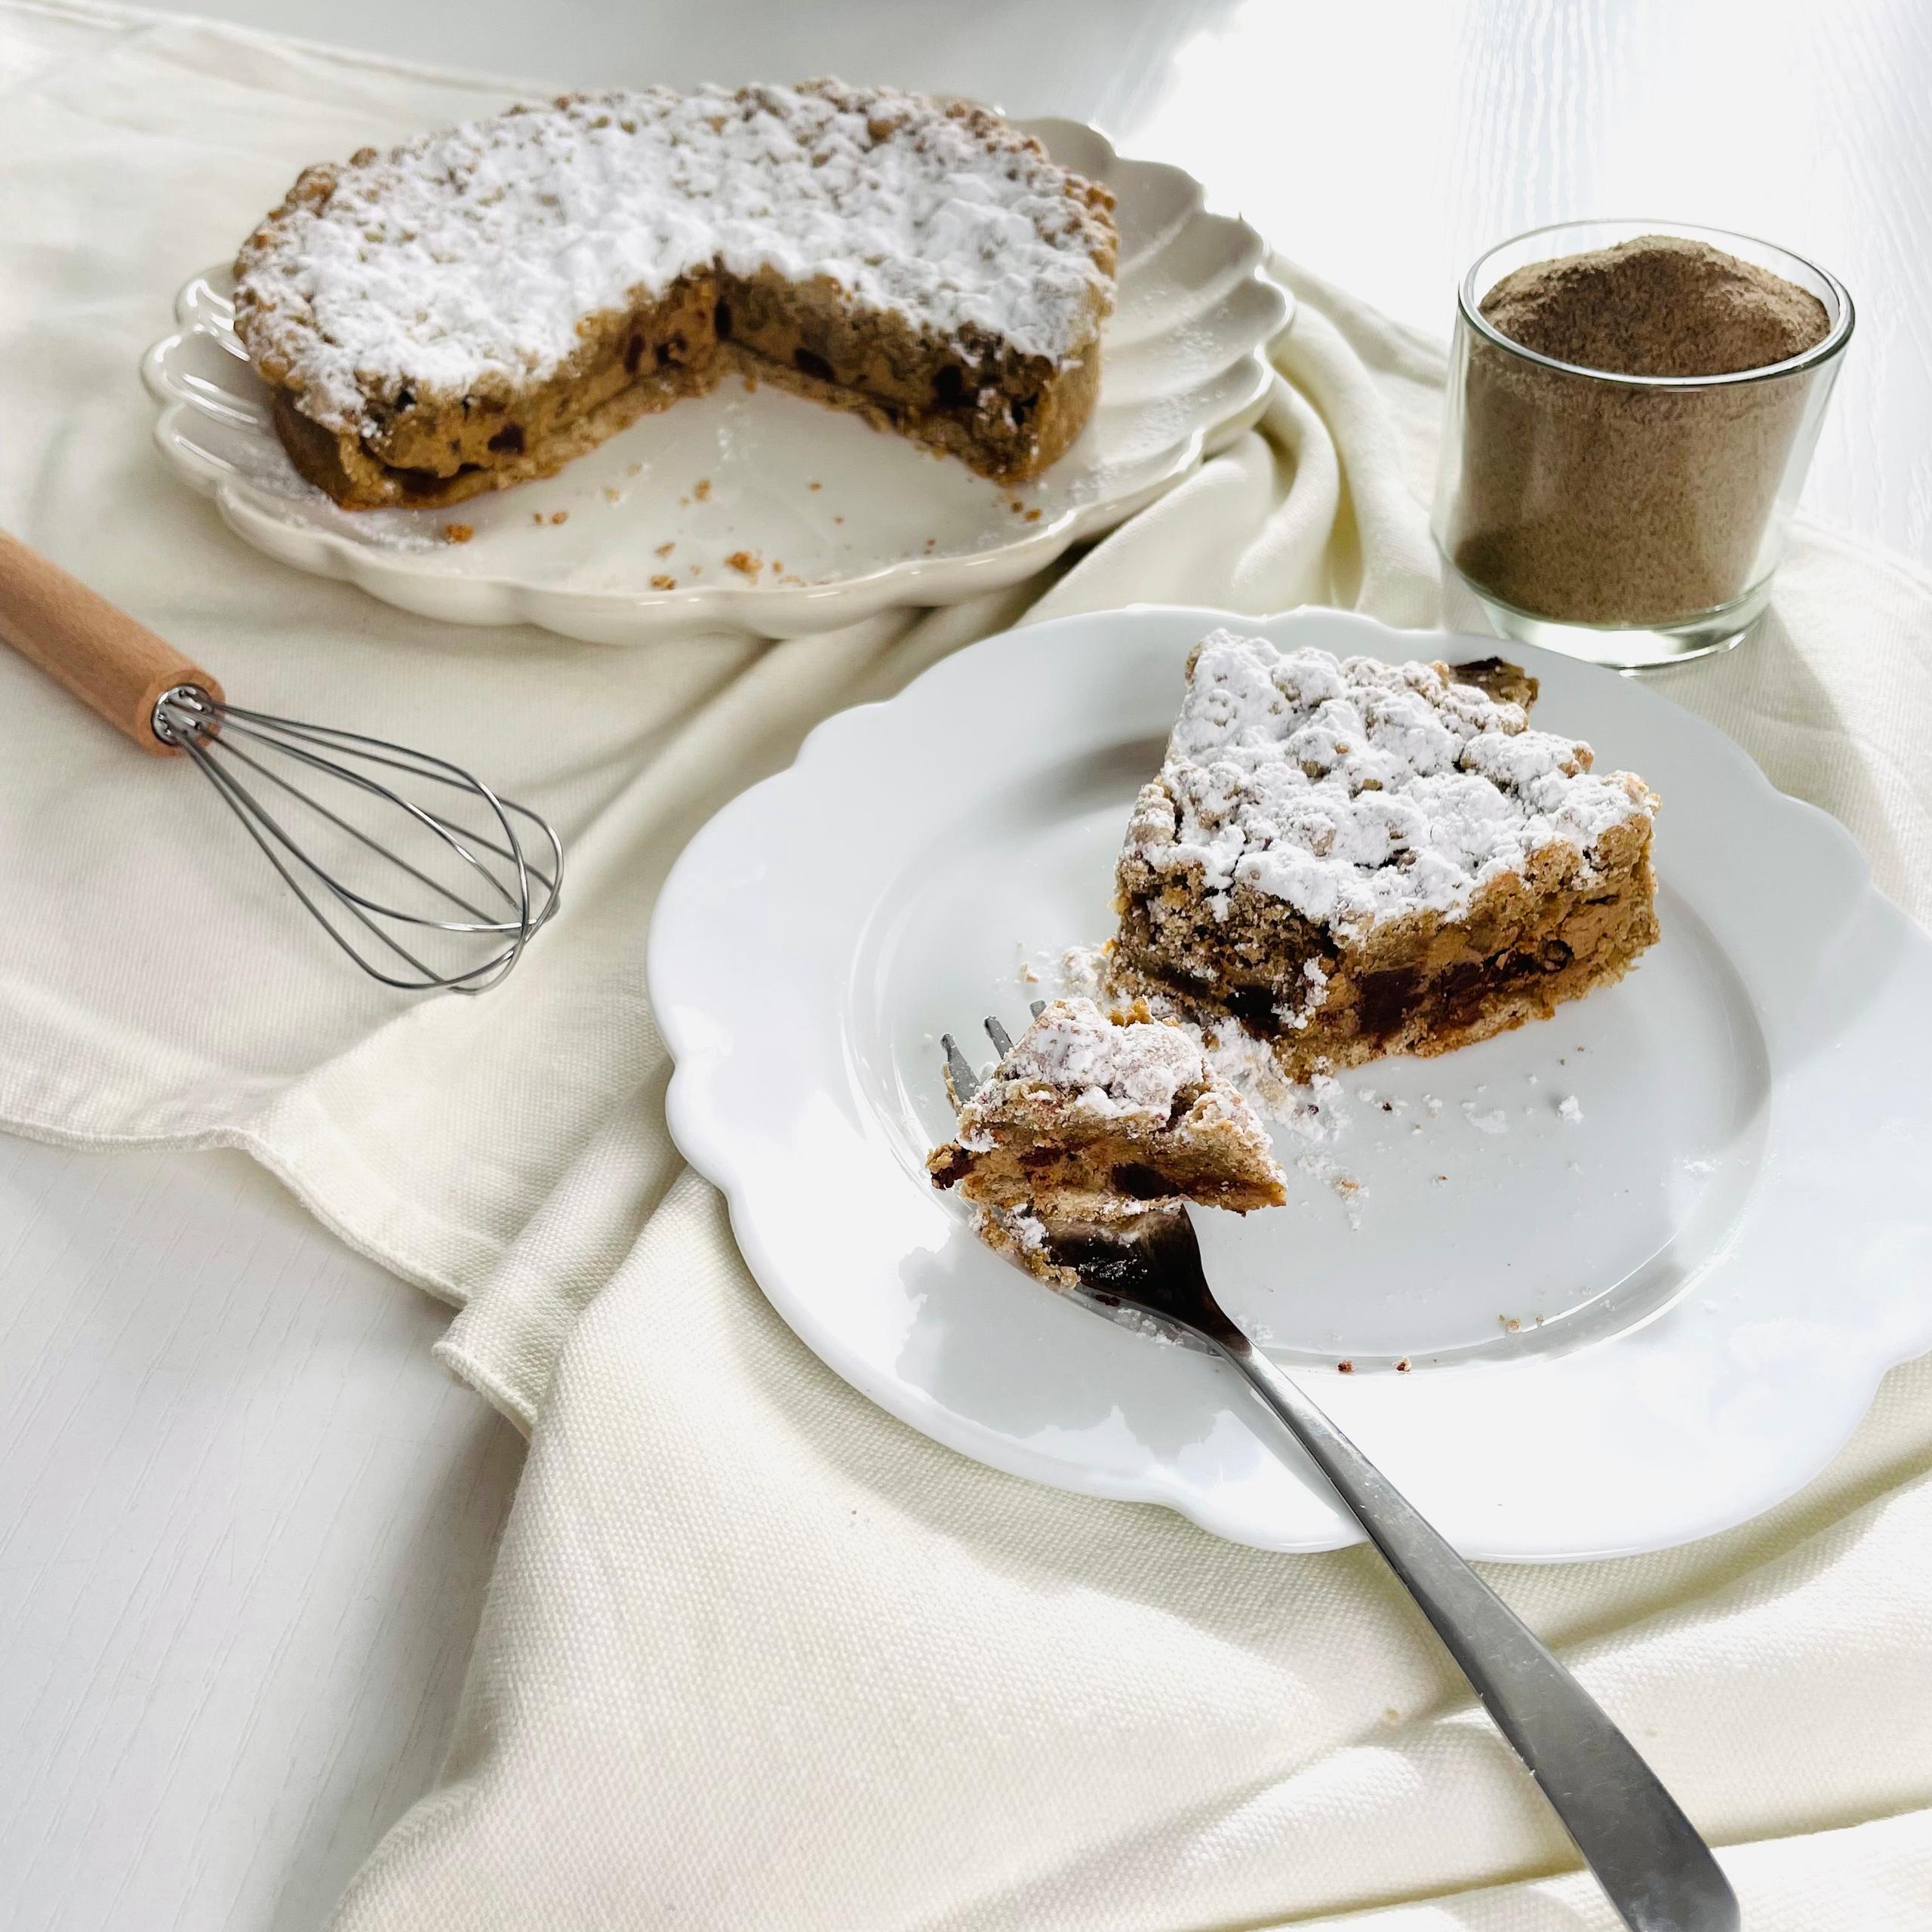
[925,999,1287,1283]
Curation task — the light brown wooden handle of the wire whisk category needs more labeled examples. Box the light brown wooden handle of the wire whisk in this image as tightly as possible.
[0,529,222,758]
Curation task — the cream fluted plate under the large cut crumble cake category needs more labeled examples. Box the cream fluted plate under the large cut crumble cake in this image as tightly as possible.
[141,120,1291,643]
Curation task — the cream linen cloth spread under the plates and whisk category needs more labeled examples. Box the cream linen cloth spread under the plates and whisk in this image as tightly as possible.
[0,0,1932,1932]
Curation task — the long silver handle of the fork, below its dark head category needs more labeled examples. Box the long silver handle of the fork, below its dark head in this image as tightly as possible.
[1208,1337,1739,1932]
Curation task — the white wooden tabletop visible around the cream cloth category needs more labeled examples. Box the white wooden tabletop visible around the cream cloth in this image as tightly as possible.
[0,0,1932,1932]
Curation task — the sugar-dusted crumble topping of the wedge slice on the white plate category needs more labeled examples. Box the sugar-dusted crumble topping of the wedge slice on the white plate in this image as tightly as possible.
[1128,630,1656,929]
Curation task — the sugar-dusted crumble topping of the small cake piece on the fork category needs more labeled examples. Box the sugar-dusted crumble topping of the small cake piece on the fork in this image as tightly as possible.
[960,999,1213,1148]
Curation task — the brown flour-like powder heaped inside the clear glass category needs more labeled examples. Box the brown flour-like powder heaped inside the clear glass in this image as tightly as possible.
[1451,235,1829,624]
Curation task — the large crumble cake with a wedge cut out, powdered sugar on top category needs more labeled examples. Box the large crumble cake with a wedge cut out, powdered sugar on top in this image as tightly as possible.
[235,82,1117,508]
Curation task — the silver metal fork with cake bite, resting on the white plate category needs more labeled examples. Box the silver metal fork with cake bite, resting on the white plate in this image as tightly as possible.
[941,1003,1739,1932]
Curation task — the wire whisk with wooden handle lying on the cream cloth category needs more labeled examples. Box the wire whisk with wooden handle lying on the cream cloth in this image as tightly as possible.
[0,531,565,993]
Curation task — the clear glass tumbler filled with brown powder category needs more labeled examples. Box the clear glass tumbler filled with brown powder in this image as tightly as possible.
[1435,222,1853,670]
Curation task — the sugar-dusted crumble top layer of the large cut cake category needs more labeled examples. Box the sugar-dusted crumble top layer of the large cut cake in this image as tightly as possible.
[238,82,1113,431]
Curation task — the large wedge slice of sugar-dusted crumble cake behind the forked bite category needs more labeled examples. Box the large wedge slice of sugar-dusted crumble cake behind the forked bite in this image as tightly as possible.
[1113,630,1657,1080]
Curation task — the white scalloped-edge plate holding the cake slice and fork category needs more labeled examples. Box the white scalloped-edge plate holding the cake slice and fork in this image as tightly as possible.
[649,608,1932,1559]
